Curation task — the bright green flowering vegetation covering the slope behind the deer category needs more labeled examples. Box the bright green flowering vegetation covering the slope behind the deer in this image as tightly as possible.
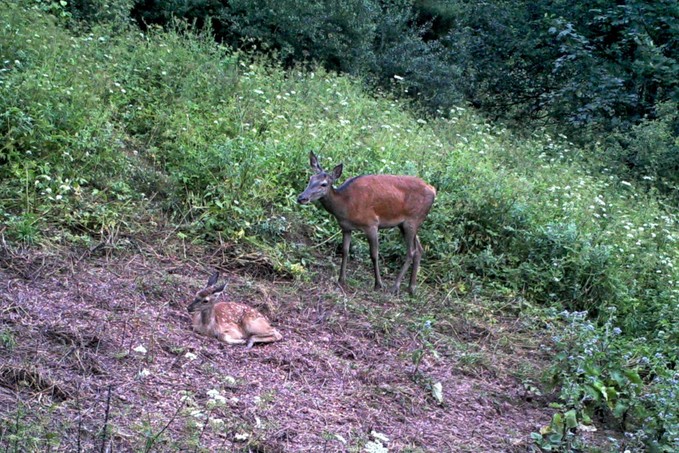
[0,1,679,451]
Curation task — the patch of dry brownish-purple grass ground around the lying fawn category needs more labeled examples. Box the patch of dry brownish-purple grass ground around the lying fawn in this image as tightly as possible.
[0,235,551,452]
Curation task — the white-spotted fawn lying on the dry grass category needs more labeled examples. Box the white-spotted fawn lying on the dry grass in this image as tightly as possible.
[188,272,283,349]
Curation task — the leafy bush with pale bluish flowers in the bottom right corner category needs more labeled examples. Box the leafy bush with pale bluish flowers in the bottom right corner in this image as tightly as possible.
[551,308,679,451]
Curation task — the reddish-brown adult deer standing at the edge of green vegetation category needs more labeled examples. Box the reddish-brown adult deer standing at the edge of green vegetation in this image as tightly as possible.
[297,151,436,294]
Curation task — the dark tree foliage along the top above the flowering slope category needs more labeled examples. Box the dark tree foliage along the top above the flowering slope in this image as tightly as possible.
[123,0,679,132]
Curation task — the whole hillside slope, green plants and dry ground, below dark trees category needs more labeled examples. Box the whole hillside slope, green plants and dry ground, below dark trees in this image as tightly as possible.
[0,0,679,451]
